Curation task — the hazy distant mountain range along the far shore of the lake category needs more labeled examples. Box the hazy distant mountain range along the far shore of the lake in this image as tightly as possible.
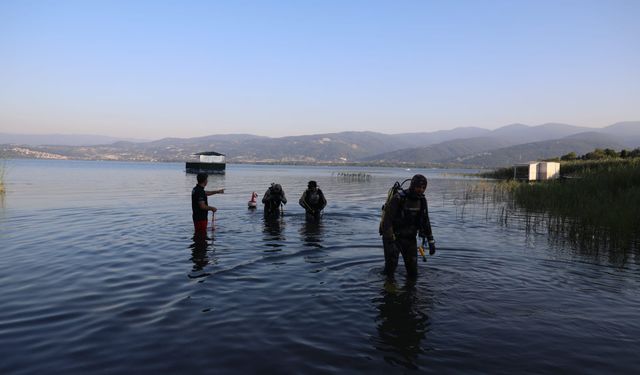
[0,121,640,167]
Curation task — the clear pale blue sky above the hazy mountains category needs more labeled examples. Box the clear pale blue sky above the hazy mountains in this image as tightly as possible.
[0,0,640,139]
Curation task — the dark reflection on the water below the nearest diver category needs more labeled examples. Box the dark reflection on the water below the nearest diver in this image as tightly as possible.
[373,280,431,369]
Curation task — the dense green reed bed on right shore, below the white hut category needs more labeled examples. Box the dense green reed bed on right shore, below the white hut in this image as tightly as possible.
[498,158,640,248]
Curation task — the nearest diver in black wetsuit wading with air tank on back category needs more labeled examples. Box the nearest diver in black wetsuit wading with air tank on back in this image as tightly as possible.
[380,174,436,279]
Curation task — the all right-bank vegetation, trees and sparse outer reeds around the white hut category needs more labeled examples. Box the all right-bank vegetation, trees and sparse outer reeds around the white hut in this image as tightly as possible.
[467,150,640,253]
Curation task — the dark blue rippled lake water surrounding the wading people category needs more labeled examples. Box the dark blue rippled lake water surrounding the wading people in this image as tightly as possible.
[0,160,640,374]
